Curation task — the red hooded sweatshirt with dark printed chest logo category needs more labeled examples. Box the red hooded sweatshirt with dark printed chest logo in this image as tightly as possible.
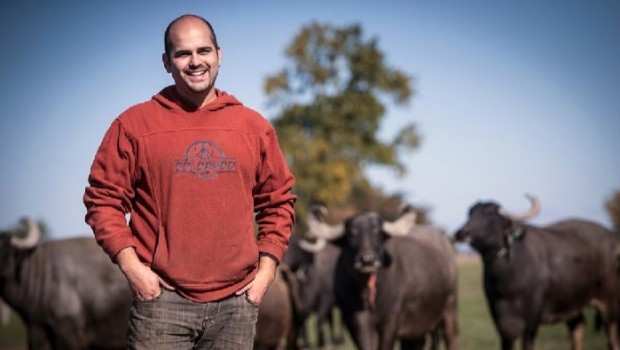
[84,87,296,302]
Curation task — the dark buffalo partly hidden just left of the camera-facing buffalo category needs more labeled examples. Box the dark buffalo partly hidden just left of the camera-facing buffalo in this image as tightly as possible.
[283,236,344,349]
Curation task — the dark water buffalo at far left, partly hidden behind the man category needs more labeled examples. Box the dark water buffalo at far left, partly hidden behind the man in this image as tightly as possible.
[0,219,131,350]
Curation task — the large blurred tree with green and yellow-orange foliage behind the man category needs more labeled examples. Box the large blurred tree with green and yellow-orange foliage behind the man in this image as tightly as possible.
[264,23,420,224]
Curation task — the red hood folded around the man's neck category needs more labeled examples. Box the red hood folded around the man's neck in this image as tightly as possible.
[153,85,242,113]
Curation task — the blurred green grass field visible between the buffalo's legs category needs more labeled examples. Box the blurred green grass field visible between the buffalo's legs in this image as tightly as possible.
[0,256,606,350]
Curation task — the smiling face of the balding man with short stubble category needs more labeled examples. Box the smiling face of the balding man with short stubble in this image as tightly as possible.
[162,17,221,107]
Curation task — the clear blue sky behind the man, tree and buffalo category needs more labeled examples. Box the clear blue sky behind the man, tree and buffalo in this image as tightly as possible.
[0,0,620,238]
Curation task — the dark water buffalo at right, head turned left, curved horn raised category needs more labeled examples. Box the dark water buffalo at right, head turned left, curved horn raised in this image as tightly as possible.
[455,196,620,350]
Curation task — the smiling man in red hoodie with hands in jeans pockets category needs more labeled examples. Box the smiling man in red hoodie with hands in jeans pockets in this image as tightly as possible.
[84,15,296,349]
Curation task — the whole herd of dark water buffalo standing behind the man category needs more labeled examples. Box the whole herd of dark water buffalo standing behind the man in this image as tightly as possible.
[0,195,620,350]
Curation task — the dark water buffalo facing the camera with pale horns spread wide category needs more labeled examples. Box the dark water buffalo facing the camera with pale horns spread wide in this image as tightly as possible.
[308,205,457,350]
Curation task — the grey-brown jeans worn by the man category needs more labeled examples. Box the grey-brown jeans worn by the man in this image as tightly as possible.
[127,289,258,350]
